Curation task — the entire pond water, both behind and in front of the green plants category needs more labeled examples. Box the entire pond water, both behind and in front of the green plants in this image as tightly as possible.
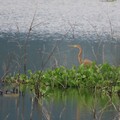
[0,0,120,120]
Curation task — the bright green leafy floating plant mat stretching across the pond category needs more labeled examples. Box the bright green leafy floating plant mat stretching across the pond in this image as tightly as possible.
[1,63,120,98]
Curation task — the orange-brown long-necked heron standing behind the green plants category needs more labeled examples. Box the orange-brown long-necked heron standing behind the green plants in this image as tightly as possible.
[69,45,93,65]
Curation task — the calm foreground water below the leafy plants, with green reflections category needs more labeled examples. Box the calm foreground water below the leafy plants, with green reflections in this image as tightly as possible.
[0,90,120,120]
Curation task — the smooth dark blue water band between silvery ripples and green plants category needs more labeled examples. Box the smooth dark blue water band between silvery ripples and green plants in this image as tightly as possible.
[0,34,120,76]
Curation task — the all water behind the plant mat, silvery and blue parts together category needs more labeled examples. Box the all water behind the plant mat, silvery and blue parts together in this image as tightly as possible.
[0,0,120,75]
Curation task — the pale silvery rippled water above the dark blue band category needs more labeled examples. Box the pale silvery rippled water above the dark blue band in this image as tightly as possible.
[0,0,120,37]
